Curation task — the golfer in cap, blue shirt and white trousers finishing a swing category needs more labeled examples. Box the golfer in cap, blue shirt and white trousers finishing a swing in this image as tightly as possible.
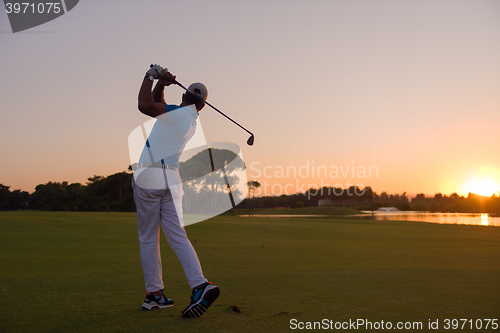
[132,65,220,318]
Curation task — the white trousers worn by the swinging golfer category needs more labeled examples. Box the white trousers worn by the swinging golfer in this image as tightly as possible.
[132,168,207,292]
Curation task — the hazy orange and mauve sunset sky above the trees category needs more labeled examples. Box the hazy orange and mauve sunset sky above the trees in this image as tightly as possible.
[0,0,500,195]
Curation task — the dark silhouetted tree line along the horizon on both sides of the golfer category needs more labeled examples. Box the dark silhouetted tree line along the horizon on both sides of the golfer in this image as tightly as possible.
[0,171,500,215]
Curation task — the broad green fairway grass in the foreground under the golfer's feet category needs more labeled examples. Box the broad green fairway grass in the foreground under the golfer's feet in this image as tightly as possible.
[0,212,500,332]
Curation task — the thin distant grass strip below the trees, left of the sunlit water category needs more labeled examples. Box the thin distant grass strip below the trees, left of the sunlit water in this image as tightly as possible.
[228,207,364,215]
